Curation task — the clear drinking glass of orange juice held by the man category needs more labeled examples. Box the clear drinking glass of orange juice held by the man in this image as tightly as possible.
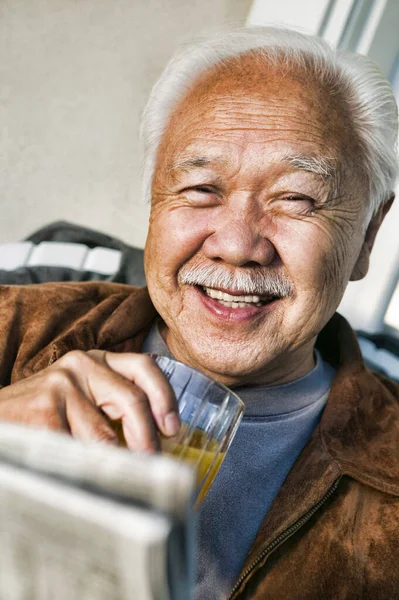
[151,354,245,506]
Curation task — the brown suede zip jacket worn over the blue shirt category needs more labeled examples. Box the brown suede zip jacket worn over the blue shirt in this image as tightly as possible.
[0,282,399,600]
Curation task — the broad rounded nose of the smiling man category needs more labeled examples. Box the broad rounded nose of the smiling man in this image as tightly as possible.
[202,199,277,267]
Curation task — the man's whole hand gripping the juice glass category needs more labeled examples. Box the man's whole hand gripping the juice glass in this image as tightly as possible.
[0,350,180,451]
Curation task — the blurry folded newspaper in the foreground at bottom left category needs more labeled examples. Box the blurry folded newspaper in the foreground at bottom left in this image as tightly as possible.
[0,423,195,600]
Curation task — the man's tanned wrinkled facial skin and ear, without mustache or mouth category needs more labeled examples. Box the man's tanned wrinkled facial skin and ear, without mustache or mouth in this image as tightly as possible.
[145,57,388,385]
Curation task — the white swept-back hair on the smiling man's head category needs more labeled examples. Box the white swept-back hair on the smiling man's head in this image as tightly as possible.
[140,27,398,224]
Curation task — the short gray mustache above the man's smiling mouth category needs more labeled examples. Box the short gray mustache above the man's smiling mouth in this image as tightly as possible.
[178,265,294,297]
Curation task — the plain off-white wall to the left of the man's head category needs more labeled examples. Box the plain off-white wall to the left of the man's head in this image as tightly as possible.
[0,0,251,245]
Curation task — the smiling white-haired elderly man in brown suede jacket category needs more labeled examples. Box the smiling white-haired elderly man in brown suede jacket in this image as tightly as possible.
[0,29,399,600]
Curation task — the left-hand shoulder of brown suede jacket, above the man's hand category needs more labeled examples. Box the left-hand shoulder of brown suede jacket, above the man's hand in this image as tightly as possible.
[0,282,154,385]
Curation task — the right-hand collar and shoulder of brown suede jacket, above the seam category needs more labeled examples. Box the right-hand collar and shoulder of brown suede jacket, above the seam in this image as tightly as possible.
[318,314,399,495]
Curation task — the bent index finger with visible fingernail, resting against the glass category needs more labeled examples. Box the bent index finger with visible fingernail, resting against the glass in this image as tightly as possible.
[90,352,180,437]
